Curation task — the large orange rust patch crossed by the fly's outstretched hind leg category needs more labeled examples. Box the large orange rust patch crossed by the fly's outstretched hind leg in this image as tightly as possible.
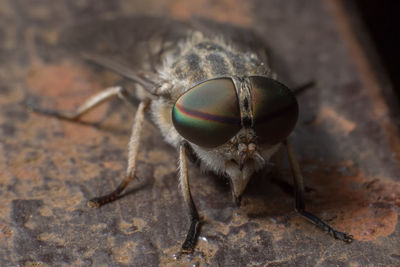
[26,61,117,143]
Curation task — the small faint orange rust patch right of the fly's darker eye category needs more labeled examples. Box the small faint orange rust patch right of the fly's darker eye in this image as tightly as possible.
[315,106,356,136]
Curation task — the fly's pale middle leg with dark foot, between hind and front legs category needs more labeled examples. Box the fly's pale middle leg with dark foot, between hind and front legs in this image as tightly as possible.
[88,100,150,208]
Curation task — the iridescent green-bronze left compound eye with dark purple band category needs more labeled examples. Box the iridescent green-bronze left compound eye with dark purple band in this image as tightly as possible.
[172,78,241,148]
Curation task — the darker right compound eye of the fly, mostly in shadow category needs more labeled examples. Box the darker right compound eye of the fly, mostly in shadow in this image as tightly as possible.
[250,76,299,144]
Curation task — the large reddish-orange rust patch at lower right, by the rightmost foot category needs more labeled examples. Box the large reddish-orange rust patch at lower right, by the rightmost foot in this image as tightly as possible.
[306,162,400,241]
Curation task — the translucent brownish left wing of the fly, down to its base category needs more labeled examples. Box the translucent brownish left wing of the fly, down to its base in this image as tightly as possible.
[60,16,195,94]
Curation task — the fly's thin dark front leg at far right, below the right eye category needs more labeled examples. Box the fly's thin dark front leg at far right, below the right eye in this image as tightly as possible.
[284,140,353,243]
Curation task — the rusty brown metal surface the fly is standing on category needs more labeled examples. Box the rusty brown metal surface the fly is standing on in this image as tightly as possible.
[0,0,400,266]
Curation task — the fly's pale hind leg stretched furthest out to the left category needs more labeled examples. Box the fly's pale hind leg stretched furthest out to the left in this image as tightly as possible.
[30,86,133,121]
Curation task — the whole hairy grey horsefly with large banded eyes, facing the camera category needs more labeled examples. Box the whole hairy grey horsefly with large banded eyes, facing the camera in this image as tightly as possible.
[33,17,352,252]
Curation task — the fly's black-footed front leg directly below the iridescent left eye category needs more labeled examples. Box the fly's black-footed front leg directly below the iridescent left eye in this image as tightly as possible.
[179,143,200,252]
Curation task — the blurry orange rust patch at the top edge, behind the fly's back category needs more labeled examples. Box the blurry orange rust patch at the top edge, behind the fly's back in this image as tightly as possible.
[168,0,253,26]
